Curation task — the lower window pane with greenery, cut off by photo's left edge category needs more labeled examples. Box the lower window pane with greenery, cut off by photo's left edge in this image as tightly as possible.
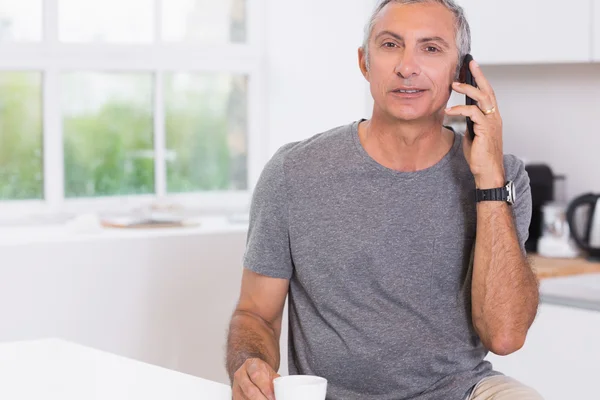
[0,72,44,200]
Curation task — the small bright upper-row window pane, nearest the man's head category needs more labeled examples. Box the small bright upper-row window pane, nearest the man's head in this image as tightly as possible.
[162,0,246,43]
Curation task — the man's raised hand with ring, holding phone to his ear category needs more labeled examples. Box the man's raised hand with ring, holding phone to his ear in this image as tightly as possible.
[446,61,505,189]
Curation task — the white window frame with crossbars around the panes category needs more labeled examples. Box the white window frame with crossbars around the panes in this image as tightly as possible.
[0,0,268,221]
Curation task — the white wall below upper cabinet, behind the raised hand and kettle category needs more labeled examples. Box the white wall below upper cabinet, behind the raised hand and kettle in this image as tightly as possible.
[484,63,600,202]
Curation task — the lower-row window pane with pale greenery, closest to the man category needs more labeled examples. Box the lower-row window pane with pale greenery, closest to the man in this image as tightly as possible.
[165,73,248,192]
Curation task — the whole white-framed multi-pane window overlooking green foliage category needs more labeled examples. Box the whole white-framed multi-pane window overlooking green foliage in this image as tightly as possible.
[0,0,263,212]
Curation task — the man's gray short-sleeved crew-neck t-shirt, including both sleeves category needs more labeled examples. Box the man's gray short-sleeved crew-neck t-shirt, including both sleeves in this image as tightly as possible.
[244,121,531,400]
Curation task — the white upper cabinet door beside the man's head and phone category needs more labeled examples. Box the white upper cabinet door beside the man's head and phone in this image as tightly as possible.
[458,0,600,64]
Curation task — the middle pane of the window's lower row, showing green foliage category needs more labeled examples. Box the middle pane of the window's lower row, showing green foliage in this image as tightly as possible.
[62,72,154,197]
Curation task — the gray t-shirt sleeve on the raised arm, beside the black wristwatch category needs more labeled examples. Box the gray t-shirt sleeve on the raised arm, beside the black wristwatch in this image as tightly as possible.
[505,156,532,253]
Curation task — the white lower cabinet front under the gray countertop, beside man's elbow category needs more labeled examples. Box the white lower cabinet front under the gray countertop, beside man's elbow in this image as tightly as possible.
[487,304,600,400]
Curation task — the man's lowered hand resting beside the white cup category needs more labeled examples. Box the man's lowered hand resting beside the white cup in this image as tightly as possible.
[231,358,279,400]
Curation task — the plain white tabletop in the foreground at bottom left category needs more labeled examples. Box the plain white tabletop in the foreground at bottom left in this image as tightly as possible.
[0,339,231,400]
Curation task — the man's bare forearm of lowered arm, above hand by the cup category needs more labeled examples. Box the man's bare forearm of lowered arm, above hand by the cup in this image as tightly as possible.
[227,311,279,381]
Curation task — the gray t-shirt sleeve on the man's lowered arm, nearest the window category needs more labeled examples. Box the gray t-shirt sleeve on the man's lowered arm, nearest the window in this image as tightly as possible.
[243,145,293,279]
